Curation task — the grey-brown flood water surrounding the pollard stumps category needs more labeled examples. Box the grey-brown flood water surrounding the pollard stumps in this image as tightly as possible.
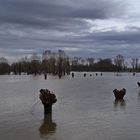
[0,73,140,140]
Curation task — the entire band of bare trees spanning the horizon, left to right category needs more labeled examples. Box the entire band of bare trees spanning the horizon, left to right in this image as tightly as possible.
[0,54,140,77]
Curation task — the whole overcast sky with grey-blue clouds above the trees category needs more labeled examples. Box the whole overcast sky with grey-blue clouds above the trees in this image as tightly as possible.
[0,0,140,58]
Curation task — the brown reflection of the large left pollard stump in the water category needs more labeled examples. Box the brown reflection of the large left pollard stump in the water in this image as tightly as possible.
[39,114,57,137]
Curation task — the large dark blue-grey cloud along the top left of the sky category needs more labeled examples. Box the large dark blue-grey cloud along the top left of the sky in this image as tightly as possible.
[0,0,120,29]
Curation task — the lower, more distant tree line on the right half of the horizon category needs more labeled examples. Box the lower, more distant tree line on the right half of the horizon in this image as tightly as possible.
[71,54,140,72]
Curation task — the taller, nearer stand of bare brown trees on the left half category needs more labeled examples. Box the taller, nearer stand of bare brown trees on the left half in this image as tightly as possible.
[0,51,70,77]
